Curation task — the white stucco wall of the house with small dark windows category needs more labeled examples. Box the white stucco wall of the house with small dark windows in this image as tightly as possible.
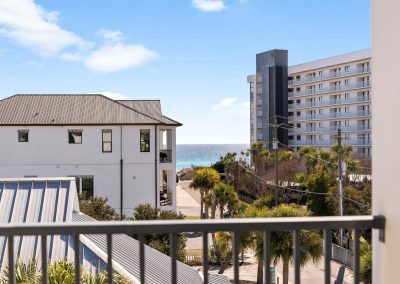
[0,125,176,215]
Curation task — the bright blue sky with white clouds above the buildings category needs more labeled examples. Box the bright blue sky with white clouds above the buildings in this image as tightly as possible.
[0,0,370,144]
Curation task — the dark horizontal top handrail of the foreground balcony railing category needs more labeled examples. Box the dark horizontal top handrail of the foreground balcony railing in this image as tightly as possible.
[0,216,385,236]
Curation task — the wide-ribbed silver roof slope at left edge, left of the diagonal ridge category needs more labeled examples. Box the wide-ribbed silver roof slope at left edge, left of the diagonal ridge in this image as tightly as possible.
[0,178,79,267]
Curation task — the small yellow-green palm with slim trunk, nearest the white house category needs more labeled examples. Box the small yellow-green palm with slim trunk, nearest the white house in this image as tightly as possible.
[190,168,220,219]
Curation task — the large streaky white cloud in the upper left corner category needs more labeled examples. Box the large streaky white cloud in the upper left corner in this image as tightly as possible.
[0,0,90,57]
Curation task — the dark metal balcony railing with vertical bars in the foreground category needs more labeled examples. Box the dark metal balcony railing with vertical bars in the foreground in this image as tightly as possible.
[0,216,385,284]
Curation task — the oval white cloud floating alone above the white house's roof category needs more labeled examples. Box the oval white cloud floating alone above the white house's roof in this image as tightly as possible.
[85,43,157,73]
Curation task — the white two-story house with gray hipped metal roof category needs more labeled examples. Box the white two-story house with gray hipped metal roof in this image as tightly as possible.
[0,94,182,215]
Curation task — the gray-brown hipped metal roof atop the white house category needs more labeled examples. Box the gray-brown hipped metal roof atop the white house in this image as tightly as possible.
[0,94,179,125]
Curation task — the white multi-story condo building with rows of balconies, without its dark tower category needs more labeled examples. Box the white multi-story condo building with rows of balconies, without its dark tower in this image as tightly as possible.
[247,49,371,158]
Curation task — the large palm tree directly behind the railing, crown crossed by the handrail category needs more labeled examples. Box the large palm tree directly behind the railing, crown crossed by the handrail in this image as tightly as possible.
[256,204,322,284]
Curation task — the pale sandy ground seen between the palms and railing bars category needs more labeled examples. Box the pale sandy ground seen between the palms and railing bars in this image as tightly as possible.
[176,181,353,284]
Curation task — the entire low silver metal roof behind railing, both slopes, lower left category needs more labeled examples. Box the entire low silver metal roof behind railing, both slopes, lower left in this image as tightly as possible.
[0,178,230,284]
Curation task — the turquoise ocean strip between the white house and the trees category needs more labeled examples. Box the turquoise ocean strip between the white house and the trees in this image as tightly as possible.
[176,144,249,171]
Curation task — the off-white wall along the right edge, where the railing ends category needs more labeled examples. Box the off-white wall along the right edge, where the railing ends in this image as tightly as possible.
[371,0,400,284]
